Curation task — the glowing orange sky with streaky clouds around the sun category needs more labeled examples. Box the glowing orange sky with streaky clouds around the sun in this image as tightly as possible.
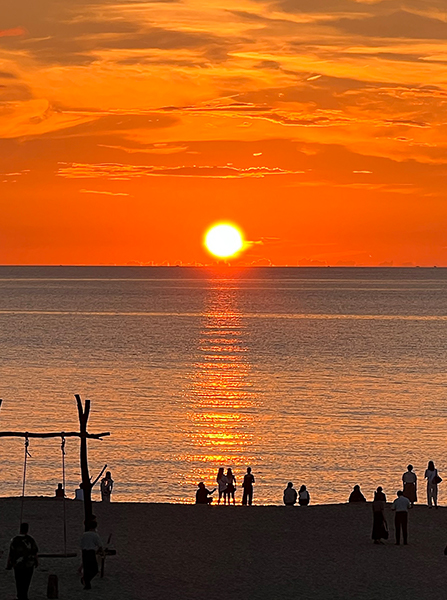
[0,0,447,266]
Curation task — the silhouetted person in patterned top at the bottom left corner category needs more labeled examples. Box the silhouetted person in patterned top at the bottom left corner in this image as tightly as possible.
[6,523,39,600]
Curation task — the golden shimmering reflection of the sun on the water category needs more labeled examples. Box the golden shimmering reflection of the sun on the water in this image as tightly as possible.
[179,280,260,502]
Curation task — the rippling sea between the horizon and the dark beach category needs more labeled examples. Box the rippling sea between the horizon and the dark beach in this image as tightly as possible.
[0,266,447,504]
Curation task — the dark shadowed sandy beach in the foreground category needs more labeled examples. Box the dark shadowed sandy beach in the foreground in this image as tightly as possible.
[0,498,447,600]
